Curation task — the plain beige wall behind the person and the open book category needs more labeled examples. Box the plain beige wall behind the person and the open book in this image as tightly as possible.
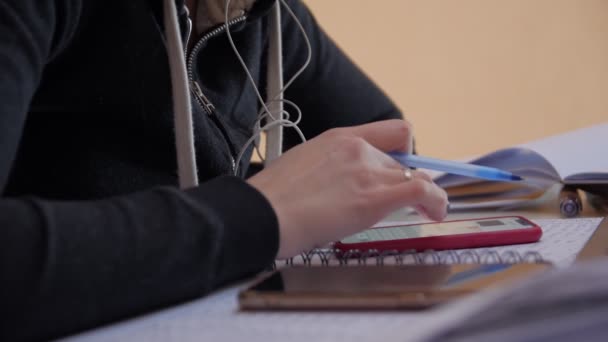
[305,0,608,158]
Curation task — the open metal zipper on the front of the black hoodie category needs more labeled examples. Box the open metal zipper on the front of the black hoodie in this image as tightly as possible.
[185,16,247,174]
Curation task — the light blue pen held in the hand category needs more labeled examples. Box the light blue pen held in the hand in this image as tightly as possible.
[388,152,523,182]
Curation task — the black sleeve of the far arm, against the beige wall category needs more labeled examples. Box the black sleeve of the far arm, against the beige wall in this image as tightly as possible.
[281,0,402,148]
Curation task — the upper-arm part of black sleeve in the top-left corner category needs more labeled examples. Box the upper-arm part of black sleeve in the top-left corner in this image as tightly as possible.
[0,0,81,190]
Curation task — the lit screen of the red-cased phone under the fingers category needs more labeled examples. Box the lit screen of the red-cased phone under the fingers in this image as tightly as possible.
[340,216,535,244]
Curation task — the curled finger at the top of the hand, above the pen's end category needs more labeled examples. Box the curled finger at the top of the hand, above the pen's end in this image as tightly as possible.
[334,119,413,152]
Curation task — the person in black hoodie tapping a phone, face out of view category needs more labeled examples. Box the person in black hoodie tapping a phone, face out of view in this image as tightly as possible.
[0,0,447,340]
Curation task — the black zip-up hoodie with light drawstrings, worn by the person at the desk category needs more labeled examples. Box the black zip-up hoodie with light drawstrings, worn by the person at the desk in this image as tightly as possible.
[0,0,400,341]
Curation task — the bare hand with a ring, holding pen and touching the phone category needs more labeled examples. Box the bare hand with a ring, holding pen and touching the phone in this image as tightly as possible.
[248,120,448,258]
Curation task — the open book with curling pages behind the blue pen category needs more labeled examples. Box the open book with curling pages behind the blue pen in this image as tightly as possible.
[435,123,608,208]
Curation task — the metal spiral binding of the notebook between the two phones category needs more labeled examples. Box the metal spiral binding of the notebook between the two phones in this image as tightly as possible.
[272,249,546,269]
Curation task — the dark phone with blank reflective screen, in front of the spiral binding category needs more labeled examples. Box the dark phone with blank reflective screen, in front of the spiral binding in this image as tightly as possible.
[239,264,549,309]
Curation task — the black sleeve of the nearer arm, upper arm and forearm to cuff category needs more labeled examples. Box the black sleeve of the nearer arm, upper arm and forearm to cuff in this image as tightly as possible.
[0,0,278,341]
